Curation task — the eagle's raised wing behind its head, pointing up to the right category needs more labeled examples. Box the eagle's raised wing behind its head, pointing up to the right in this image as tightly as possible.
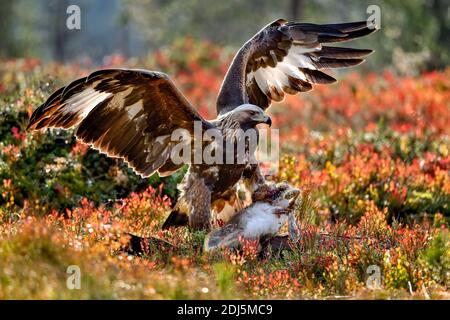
[217,19,376,114]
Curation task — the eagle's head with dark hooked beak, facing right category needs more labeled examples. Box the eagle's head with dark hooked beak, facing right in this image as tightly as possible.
[219,104,272,130]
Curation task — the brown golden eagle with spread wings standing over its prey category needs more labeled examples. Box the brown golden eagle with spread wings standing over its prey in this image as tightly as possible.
[29,19,376,229]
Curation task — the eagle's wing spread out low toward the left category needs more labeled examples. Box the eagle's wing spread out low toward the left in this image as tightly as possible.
[29,69,210,177]
